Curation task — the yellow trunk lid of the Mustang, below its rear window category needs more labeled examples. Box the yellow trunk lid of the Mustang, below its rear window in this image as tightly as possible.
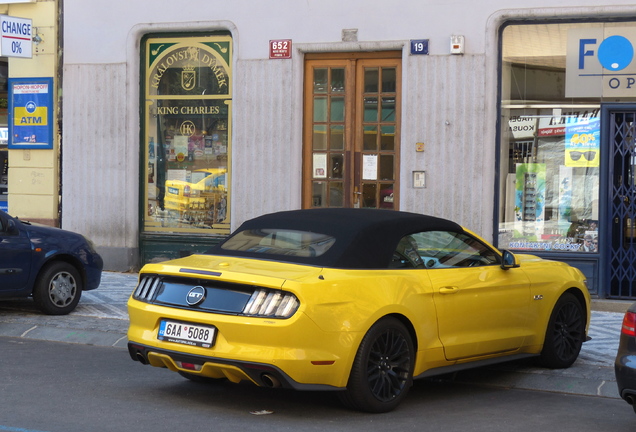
[141,255,322,287]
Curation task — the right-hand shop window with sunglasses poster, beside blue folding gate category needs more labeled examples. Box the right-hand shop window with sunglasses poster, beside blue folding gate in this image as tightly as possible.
[499,23,602,253]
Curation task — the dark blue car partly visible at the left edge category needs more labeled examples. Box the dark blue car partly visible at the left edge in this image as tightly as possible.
[0,210,103,315]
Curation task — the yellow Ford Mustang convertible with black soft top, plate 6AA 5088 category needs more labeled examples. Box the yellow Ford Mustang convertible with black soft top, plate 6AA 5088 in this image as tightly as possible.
[128,209,590,412]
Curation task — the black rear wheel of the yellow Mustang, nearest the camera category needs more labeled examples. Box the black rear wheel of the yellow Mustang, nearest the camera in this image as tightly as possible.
[338,317,415,413]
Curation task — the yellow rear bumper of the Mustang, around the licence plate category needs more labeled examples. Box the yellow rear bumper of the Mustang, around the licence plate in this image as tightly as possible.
[128,298,363,390]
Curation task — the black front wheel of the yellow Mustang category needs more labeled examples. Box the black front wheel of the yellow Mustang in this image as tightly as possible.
[538,293,585,369]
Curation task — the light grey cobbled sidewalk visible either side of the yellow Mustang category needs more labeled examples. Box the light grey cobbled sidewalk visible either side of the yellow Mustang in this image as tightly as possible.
[0,272,630,398]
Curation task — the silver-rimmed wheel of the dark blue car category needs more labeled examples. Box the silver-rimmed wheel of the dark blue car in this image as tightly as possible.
[33,261,83,315]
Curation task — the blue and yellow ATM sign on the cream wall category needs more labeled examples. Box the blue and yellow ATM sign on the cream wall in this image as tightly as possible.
[9,78,53,149]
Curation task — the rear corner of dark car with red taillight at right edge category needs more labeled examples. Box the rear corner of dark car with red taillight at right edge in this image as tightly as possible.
[614,303,636,412]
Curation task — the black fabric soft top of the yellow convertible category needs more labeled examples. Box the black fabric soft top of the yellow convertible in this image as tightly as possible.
[208,208,464,269]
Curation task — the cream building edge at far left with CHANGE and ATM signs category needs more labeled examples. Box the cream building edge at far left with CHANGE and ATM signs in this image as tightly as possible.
[0,0,61,226]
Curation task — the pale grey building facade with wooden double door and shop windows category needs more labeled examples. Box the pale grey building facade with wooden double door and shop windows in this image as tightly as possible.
[43,0,636,298]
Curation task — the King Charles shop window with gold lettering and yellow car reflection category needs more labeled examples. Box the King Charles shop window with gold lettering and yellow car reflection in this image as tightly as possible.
[143,36,232,234]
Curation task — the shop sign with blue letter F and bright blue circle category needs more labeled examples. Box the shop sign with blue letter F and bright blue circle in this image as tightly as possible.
[565,27,636,98]
